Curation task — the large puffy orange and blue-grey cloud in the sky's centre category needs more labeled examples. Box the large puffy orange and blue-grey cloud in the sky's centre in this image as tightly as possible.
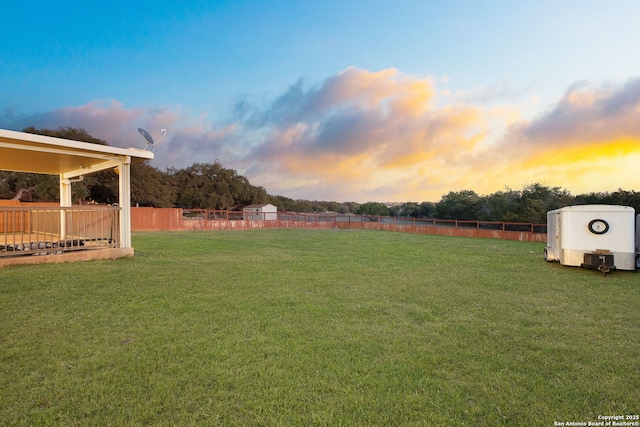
[238,68,487,200]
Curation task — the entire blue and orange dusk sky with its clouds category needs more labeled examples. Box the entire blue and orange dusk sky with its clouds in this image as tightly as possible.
[0,0,640,202]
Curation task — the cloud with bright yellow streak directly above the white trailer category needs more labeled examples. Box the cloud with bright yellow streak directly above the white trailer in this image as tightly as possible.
[481,78,640,196]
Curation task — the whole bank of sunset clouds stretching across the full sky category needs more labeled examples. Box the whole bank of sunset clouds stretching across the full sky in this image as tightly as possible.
[2,67,640,202]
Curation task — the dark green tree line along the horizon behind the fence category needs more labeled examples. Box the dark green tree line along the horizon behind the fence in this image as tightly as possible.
[0,127,640,223]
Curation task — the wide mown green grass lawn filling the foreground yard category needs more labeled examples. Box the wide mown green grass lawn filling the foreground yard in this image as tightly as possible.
[0,229,640,426]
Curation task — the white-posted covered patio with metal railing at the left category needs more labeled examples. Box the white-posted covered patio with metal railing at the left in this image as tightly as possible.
[0,129,153,267]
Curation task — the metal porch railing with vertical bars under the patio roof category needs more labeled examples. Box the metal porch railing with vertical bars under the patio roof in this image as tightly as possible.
[0,206,120,257]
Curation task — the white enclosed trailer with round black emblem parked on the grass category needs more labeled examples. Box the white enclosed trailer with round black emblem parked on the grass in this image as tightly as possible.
[544,205,640,271]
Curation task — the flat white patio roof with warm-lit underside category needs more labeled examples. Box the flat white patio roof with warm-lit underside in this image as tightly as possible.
[0,129,153,178]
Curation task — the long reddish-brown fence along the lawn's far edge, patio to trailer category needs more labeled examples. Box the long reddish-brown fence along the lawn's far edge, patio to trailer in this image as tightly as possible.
[131,208,547,242]
